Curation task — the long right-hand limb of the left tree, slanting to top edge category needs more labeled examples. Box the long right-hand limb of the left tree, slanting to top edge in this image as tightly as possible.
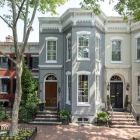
[20,0,40,60]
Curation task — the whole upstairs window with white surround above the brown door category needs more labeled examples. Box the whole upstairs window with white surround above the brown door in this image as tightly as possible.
[46,37,57,63]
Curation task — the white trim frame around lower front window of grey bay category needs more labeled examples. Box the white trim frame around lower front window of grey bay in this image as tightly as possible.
[76,71,91,106]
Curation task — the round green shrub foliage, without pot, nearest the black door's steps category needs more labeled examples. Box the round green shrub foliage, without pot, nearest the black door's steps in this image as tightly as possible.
[97,111,109,122]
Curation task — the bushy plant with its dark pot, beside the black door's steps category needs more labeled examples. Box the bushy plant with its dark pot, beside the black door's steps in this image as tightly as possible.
[96,111,109,126]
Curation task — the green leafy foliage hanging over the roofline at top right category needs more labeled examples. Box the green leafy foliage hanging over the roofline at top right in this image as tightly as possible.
[80,0,140,22]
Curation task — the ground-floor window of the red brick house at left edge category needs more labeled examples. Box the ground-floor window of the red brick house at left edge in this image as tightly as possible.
[1,78,10,93]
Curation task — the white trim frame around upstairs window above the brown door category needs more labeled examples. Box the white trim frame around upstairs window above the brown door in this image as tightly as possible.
[45,37,58,63]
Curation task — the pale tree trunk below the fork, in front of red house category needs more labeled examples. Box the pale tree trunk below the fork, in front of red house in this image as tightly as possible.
[10,61,22,136]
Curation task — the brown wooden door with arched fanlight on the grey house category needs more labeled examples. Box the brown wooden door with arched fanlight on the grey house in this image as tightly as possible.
[45,74,57,107]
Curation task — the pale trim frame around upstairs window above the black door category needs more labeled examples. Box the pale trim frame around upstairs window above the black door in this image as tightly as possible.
[110,37,123,64]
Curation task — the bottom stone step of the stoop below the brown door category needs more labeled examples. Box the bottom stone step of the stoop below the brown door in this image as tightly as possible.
[30,121,62,125]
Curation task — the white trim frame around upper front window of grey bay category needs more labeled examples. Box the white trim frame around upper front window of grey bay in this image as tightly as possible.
[76,31,91,61]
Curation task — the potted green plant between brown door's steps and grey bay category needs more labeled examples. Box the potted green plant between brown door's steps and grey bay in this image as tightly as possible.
[60,110,69,125]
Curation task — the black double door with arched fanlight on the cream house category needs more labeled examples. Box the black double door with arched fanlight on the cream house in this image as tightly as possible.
[110,75,123,108]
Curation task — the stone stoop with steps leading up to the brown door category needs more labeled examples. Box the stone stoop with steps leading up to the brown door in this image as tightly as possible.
[30,108,62,125]
